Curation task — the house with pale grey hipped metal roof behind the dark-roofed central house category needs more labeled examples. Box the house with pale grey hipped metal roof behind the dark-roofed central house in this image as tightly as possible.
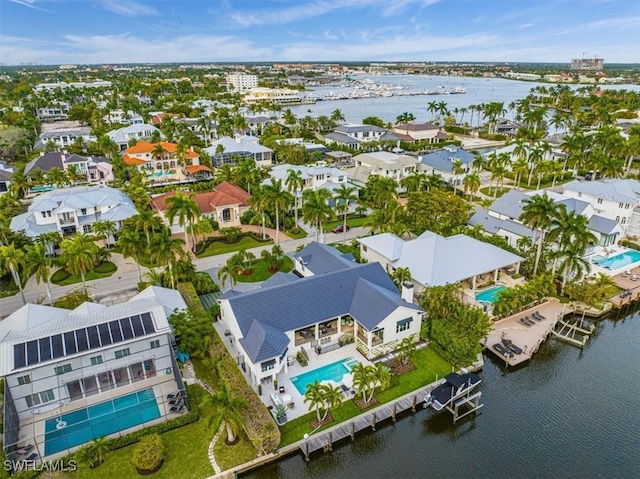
[357,231,524,292]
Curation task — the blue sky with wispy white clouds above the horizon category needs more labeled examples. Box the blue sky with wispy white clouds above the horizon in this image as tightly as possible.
[0,0,640,64]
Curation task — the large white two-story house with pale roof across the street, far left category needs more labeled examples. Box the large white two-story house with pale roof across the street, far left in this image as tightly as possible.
[10,186,138,238]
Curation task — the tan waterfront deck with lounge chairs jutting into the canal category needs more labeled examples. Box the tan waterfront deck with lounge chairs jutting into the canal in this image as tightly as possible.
[483,300,568,366]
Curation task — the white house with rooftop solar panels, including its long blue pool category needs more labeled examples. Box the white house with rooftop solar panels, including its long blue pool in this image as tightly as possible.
[0,286,186,460]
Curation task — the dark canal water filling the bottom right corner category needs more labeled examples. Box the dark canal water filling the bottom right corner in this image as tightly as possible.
[243,310,640,479]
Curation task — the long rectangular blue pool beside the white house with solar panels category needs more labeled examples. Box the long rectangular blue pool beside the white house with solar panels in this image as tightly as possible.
[44,388,160,456]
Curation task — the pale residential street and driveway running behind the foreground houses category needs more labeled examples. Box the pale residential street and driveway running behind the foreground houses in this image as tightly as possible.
[0,227,368,318]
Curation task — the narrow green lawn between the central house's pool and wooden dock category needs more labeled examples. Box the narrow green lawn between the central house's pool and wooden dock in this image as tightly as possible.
[280,348,451,447]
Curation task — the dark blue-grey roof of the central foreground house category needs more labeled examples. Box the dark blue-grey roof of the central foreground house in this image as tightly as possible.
[221,263,420,363]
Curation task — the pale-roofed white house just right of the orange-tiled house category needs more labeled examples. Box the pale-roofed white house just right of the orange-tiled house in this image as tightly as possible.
[204,135,273,168]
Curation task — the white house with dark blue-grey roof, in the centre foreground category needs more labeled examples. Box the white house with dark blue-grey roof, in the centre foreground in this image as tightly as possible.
[218,243,423,385]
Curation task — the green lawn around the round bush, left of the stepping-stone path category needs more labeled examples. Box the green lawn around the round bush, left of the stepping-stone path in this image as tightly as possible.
[69,394,214,479]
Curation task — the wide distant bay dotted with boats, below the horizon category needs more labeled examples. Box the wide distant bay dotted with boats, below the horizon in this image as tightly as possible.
[291,75,640,125]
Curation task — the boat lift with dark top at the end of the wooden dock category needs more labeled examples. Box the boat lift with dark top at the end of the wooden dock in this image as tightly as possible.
[425,373,484,423]
